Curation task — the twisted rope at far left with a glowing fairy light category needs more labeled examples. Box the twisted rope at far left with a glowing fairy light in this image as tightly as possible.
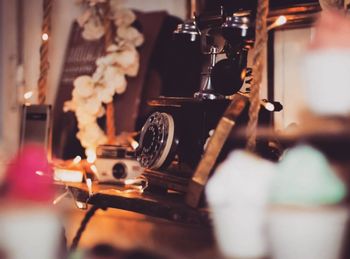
[38,0,53,104]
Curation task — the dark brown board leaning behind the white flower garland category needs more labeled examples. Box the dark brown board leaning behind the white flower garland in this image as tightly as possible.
[53,11,172,159]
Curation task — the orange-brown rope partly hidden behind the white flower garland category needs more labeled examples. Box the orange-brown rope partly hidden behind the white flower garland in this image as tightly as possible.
[104,1,116,144]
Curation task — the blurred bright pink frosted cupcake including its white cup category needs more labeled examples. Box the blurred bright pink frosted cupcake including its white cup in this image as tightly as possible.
[0,144,62,259]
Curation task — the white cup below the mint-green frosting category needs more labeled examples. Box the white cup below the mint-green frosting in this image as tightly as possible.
[268,206,349,259]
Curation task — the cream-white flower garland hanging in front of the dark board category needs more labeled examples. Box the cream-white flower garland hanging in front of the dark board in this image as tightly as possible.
[63,0,144,153]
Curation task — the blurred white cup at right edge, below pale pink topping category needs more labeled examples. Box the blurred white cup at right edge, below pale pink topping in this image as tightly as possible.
[300,49,350,116]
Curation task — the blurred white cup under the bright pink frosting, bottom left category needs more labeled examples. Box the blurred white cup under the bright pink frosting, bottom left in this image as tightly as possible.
[0,208,62,259]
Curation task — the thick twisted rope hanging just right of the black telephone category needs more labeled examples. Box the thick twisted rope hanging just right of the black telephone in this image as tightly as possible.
[247,0,269,151]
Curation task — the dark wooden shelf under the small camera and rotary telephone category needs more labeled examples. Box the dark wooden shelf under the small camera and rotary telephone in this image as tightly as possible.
[59,183,211,227]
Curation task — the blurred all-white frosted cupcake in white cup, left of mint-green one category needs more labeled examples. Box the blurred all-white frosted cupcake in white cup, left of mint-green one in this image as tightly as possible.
[206,150,275,258]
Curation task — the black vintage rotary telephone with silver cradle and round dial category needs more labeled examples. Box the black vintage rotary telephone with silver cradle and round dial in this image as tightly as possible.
[137,6,282,191]
